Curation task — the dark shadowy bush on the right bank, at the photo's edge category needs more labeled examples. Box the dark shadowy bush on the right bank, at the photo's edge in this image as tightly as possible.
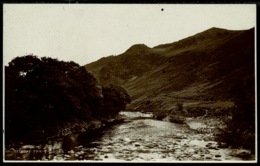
[219,86,256,153]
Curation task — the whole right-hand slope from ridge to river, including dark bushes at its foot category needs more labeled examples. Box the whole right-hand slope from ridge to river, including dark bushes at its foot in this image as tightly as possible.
[85,28,255,152]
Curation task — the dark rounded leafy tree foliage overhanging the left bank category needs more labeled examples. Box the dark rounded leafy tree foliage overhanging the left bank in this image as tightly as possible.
[5,55,132,143]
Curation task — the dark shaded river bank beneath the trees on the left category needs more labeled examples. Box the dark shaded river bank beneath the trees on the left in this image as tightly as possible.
[4,115,124,161]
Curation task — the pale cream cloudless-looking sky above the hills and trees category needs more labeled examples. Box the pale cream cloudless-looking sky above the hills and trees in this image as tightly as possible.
[3,4,256,65]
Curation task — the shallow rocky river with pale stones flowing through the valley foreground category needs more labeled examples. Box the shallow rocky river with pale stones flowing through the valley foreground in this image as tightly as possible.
[6,112,252,162]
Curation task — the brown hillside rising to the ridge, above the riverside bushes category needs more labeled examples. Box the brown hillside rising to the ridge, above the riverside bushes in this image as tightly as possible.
[85,28,254,111]
